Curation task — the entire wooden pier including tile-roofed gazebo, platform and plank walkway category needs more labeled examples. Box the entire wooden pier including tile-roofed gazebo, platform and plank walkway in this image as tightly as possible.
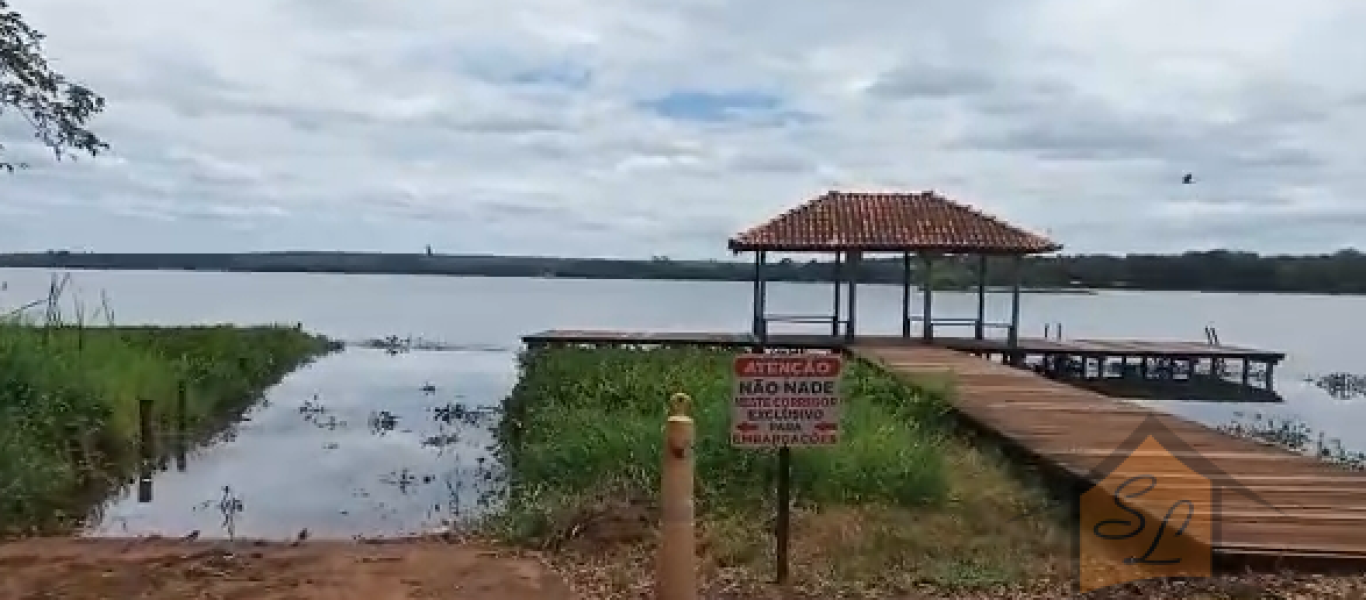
[523,191,1366,573]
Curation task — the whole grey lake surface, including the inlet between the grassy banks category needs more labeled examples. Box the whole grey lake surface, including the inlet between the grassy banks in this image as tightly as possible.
[0,269,1366,538]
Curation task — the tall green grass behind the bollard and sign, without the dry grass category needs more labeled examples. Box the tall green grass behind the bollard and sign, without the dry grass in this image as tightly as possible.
[500,349,952,537]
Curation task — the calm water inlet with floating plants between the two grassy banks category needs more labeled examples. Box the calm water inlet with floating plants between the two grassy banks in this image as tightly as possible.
[87,349,515,538]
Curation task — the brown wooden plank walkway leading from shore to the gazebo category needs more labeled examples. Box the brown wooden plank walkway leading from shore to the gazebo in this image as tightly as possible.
[846,342,1366,570]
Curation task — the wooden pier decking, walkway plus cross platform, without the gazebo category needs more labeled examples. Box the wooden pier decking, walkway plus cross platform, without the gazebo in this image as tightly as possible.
[523,329,1366,571]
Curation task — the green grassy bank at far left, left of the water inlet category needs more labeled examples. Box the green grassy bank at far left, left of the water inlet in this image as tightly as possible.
[0,323,331,534]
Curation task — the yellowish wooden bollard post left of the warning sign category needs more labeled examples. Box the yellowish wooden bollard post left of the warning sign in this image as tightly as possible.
[654,394,697,600]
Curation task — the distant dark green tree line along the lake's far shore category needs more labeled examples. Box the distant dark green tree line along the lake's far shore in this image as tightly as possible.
[0,250,1366,294]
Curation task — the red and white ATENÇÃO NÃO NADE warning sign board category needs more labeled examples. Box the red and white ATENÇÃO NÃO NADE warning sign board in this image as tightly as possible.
[731,354,844,448]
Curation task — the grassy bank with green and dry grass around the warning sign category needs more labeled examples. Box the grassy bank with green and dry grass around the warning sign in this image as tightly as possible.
[494,349,1068,596]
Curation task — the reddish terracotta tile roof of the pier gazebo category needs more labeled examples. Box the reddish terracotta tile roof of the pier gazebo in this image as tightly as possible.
[728,191,1063,254]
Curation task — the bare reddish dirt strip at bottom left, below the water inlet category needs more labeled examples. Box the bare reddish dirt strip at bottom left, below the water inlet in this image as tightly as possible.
[0,538,574,600]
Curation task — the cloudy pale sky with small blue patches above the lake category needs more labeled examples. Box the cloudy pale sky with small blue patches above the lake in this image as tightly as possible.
[0,0,1366,257]
